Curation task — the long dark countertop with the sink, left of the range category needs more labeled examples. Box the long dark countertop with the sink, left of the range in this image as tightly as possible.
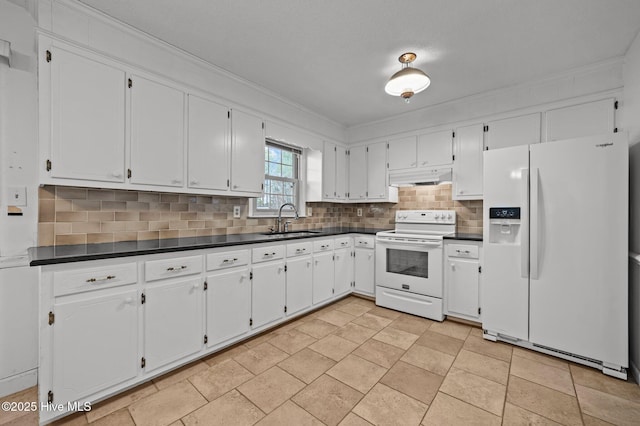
[29,227,382,266]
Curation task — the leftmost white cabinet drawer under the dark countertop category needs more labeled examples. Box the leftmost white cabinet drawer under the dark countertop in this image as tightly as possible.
[53,262,138,296]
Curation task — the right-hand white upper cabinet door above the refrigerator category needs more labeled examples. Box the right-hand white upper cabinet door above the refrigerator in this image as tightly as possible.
[546,98,615,142]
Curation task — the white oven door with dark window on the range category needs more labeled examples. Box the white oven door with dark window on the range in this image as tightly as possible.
[376,237,443,298]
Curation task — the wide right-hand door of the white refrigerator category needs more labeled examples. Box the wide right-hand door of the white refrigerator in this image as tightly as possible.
[530,134,629,366]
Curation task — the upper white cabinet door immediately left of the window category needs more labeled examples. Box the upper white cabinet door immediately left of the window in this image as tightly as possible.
[231,109,264,194]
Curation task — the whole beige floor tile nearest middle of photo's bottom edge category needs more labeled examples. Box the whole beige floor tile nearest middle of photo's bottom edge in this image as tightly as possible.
[292,374,362,426]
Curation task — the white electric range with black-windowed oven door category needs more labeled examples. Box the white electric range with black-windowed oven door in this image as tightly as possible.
[376,210,456,321]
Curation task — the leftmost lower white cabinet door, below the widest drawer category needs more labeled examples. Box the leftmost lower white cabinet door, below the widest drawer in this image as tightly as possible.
[52,290,140,402]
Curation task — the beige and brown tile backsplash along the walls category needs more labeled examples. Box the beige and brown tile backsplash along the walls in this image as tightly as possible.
[38,185,482,246]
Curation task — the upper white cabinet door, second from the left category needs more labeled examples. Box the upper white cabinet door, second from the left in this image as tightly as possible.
[130,76,184,187]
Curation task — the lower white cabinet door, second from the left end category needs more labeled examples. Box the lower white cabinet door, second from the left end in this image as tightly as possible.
[144,278,204,371]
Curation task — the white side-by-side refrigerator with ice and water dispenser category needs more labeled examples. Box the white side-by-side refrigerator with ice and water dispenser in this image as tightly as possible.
[482,134,629,378]
